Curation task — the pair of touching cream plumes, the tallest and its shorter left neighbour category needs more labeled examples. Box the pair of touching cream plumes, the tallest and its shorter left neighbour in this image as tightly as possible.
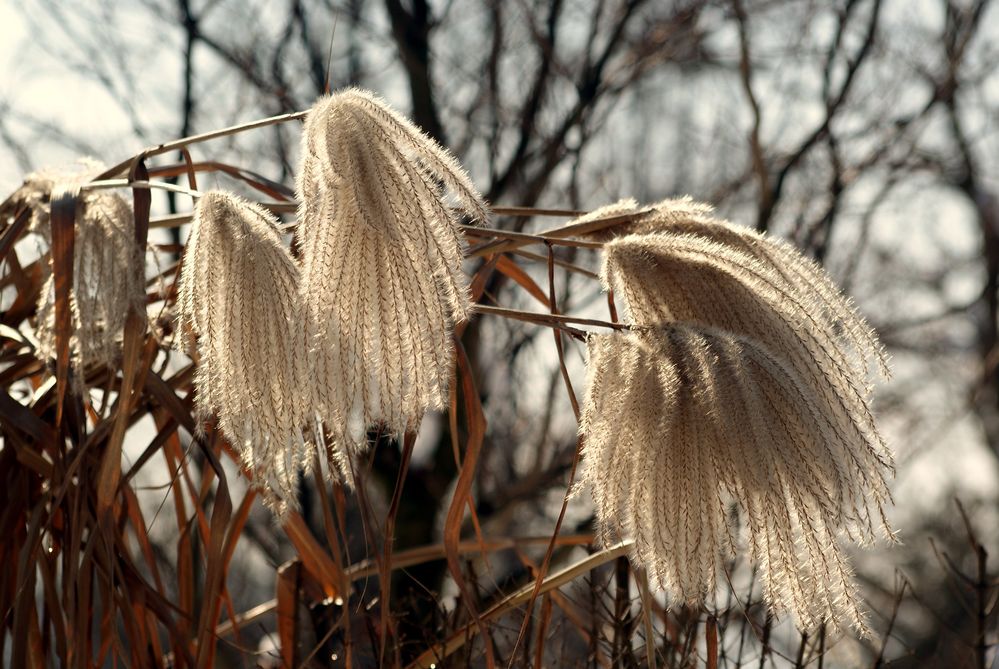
[179,89,487,506]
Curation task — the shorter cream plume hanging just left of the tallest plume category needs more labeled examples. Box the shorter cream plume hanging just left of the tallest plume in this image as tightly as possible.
[177,191,322,513]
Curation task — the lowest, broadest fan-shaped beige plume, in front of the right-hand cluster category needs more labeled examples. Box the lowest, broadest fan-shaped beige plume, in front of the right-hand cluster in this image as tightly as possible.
[581,323,886,629]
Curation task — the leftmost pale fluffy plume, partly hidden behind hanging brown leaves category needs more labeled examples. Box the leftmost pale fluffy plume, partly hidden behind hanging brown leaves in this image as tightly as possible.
[15,161,145,374]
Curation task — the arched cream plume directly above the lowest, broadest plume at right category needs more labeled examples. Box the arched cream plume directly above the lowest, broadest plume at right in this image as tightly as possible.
[601,233,888,446]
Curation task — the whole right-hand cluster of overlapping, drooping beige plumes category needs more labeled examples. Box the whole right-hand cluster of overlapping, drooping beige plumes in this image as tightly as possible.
[581,200,892,629]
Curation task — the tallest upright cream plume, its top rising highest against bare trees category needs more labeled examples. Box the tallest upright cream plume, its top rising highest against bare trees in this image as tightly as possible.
[297,89,487,446]
